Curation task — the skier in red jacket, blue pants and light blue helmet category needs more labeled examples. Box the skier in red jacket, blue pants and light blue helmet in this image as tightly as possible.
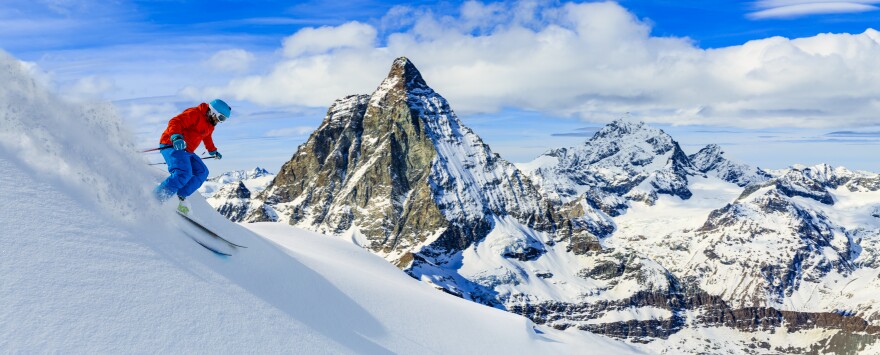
[154,99,232,214]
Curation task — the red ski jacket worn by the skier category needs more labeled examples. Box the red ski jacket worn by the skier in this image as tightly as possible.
[159,102,217,153]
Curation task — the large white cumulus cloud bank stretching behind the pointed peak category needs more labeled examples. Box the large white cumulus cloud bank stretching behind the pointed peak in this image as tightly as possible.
[191,1,880,127]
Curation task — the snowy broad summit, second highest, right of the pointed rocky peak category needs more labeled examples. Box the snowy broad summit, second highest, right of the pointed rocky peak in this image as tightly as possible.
[520,119,701,220]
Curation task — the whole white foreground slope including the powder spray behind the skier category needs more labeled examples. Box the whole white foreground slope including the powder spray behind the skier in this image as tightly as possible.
[0,53,637,354]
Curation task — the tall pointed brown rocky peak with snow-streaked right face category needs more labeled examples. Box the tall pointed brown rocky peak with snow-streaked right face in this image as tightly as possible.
[247,58,598,268]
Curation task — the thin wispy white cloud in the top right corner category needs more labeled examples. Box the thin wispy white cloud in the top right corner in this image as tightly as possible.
[747,0,880,20]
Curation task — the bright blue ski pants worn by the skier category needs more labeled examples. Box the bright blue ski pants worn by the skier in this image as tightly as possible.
[159,148,208,197]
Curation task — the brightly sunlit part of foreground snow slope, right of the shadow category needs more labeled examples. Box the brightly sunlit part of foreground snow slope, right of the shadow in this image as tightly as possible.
[245,222,638,354]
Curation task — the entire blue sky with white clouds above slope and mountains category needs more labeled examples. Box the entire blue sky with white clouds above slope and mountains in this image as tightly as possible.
[0,0,880,172]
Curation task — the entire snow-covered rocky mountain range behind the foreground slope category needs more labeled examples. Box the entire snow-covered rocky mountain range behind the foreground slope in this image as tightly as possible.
[203,58,880,353]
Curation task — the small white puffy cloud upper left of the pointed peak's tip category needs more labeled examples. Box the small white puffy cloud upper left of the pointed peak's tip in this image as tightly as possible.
[283,21,376,57]
